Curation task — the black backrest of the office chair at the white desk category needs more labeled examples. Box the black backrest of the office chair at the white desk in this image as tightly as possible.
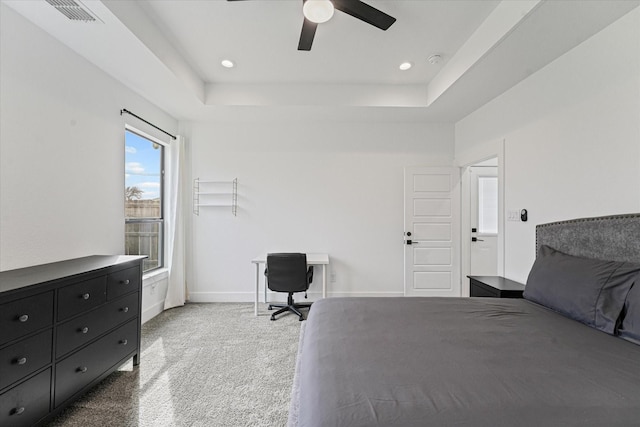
[265,253,309,292]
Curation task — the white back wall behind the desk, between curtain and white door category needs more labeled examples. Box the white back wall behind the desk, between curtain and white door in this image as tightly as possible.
[188,117,453,301]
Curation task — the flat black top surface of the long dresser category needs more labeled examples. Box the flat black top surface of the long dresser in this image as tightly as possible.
[0,255,146,293]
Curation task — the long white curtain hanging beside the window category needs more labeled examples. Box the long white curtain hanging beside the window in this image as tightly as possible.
[164,136,187,310]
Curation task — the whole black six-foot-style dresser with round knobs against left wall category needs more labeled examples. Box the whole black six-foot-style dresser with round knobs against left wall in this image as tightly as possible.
[0,255,145,427]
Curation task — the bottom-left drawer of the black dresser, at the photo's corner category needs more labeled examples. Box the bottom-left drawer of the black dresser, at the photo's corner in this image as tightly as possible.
[0,369,51,427]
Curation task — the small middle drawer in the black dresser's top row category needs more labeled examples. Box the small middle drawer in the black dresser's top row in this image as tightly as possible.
[58,276,107,320]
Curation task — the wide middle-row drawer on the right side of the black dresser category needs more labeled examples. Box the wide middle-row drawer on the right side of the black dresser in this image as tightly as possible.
[56,293,140,358]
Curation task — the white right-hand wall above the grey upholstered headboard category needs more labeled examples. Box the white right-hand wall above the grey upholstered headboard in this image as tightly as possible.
[455,9,640,282]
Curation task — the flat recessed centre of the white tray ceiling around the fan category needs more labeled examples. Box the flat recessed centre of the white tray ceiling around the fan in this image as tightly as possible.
[140,0,499,84]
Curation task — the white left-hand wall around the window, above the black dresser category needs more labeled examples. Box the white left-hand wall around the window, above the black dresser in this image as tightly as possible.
[0,4,178,318]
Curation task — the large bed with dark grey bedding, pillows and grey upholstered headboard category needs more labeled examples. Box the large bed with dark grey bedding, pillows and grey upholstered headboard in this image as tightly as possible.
[290,215,640,427]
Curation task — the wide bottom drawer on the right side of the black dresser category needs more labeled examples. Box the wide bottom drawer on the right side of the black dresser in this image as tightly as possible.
[55,320,138,407]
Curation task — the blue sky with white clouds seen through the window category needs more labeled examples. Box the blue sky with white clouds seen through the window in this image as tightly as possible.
[124,130,162,200]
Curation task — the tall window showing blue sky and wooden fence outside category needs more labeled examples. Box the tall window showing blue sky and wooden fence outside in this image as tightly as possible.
[124,129,164,272]
